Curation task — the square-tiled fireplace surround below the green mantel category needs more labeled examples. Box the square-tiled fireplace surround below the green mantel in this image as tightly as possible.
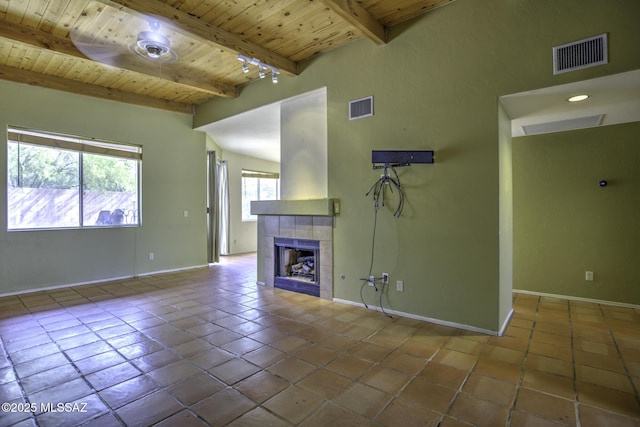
[252,202,334,300]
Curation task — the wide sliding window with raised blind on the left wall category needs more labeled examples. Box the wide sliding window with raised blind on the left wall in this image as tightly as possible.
[7,128,142,230]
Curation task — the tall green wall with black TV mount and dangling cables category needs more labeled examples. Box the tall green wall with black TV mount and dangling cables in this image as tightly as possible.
[194,0,640,331]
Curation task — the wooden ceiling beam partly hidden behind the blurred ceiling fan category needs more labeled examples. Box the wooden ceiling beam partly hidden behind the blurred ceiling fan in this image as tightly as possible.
[0,21,238,98]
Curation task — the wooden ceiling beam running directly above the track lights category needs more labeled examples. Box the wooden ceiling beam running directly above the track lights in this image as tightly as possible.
[103,0,298,76]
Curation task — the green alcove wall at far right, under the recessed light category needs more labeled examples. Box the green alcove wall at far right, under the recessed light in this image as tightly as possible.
[513,123,640,304]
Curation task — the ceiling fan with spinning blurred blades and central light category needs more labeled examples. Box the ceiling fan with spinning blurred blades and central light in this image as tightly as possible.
[69,3,179,67]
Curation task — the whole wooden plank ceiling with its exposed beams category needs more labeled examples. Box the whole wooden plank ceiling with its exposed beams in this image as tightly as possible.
[0,0,453,114]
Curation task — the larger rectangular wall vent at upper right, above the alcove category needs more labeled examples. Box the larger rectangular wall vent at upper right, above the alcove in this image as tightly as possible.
[553,33,609,74]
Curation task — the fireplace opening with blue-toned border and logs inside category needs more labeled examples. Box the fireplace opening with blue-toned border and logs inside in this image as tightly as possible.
[274,237,320,297]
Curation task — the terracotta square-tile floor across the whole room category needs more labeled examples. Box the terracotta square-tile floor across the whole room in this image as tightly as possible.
[0,255,640,427]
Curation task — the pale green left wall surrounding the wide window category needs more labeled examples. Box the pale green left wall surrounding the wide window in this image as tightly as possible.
[0,81,207,294]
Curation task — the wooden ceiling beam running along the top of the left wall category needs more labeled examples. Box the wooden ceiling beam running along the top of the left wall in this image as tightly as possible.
[0,65,194,114]
